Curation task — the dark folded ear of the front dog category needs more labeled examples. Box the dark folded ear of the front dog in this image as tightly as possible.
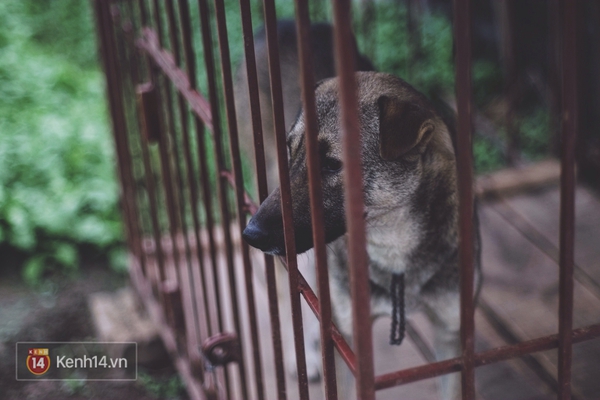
[377,96,434,161]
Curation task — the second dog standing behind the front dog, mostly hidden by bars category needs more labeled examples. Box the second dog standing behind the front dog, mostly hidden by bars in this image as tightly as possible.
[234,20,374,381]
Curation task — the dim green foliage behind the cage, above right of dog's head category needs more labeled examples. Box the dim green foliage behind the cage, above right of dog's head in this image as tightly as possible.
[355,3,505,172]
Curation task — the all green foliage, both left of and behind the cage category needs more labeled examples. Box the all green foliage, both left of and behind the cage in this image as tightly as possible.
[0,0,552,284]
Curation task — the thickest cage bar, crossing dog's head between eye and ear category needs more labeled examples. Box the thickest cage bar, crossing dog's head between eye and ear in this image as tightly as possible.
[333,0,375,400]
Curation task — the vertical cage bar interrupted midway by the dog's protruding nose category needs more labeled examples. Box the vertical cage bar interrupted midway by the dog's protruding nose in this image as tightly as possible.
[239,0,286,399]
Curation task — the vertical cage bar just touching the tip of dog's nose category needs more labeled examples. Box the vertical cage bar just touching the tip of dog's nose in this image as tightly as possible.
[215,0,264,399]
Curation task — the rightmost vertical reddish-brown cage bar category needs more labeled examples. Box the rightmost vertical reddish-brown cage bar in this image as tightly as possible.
[558,0,579,400]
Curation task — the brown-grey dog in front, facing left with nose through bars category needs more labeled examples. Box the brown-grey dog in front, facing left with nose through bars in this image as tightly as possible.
[243,72,481,399]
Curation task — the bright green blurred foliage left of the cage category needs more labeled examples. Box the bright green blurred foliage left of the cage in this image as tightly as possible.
[0,0,122,284]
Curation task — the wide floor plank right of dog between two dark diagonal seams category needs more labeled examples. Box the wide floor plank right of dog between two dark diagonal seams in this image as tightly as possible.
[480,205,600,398]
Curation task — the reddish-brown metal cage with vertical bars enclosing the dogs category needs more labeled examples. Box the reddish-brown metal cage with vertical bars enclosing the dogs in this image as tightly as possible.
[94,0,600,400]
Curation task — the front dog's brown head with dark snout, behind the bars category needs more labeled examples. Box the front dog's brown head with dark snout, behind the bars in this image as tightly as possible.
[243,72,454,255]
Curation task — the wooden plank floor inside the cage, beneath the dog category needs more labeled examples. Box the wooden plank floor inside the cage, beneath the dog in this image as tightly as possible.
[252,185,600,400]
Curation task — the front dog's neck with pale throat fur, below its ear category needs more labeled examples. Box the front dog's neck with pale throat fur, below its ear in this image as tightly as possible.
[367,125,458,274]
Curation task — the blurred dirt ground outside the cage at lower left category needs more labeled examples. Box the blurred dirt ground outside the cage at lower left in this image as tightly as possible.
[0,264,187,400]
